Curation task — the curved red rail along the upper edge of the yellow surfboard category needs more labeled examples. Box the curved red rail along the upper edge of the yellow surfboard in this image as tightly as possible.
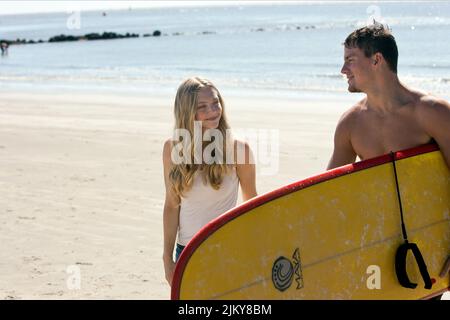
[171,143,439,300]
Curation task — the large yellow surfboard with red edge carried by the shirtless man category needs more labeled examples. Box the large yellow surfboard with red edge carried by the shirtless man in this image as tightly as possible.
[172,144,450,299]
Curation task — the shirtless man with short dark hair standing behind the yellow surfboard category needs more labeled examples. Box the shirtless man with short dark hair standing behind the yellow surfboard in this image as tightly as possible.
[328,23,450,169]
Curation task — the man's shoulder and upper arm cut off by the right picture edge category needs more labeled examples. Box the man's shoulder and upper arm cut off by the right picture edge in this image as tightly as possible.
[417,97,450,168]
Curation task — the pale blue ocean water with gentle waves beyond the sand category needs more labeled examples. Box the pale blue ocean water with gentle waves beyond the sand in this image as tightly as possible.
[0,1,450,97]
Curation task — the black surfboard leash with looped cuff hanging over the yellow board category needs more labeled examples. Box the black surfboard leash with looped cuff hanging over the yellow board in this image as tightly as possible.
[390,151,433,289]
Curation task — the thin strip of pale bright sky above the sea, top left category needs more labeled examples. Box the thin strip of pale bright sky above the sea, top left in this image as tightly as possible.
[0,0,285,15]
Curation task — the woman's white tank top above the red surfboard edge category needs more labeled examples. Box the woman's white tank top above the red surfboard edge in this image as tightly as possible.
[178,167,239,246]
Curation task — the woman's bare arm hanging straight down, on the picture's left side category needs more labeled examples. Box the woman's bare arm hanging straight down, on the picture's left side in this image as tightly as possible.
[163,140,180,285]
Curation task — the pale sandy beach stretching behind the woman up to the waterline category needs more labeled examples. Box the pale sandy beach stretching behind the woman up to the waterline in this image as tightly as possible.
[0,90,356,299]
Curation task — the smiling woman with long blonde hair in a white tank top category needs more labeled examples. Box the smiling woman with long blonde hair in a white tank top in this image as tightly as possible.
[163,77,256,285]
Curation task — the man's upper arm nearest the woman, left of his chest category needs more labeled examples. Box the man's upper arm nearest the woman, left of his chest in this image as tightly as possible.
[327,108,356,170]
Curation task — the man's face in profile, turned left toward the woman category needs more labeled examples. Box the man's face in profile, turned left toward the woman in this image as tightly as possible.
[341,48,373,92]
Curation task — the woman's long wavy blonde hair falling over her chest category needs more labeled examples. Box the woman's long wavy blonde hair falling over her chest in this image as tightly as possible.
[169,77,230,197]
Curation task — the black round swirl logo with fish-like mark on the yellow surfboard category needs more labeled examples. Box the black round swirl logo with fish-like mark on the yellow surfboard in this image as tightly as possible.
[272,248,303,292]
